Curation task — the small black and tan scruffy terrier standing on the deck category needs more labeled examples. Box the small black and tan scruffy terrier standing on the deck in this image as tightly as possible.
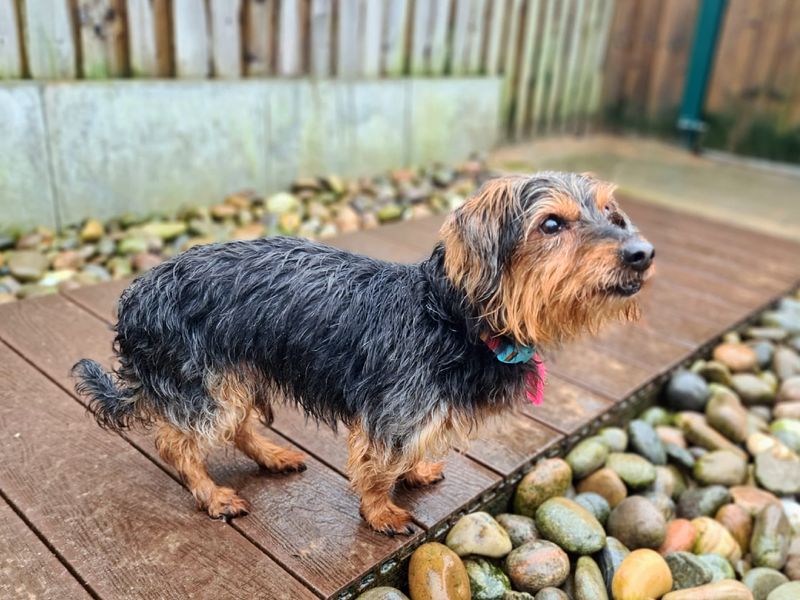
[73,172,654,534]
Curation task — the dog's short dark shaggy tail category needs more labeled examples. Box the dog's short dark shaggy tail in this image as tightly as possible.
[71,358,141,431]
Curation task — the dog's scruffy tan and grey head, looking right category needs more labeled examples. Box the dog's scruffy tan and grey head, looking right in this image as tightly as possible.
[442,172,655,345]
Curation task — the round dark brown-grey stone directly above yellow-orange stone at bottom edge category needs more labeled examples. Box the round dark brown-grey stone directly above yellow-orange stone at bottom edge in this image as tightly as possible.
[606,496,667,550]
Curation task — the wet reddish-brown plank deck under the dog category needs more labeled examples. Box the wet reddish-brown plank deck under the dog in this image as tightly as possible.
[0,200,800,599]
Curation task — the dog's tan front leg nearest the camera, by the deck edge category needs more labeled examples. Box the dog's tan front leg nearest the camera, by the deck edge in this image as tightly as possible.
[347,425,414,535]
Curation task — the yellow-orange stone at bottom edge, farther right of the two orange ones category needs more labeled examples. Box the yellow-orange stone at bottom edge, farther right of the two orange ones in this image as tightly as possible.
[611,548,672,600]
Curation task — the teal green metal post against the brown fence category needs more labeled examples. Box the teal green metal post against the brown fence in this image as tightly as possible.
[678,0,727,150]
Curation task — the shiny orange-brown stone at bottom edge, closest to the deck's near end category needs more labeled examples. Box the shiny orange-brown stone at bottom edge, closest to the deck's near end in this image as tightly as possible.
[408,542,471,600]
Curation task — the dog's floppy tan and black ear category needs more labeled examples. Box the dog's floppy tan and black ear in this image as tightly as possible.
[441,177,522,302]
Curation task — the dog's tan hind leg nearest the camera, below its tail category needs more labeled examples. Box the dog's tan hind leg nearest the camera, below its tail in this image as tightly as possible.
[156,423,250,519]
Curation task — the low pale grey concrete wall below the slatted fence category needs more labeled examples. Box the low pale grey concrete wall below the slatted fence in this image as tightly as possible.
[0,78,500,229]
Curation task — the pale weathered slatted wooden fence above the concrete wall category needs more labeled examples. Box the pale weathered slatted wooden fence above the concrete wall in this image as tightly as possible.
[0,0,614,137]
